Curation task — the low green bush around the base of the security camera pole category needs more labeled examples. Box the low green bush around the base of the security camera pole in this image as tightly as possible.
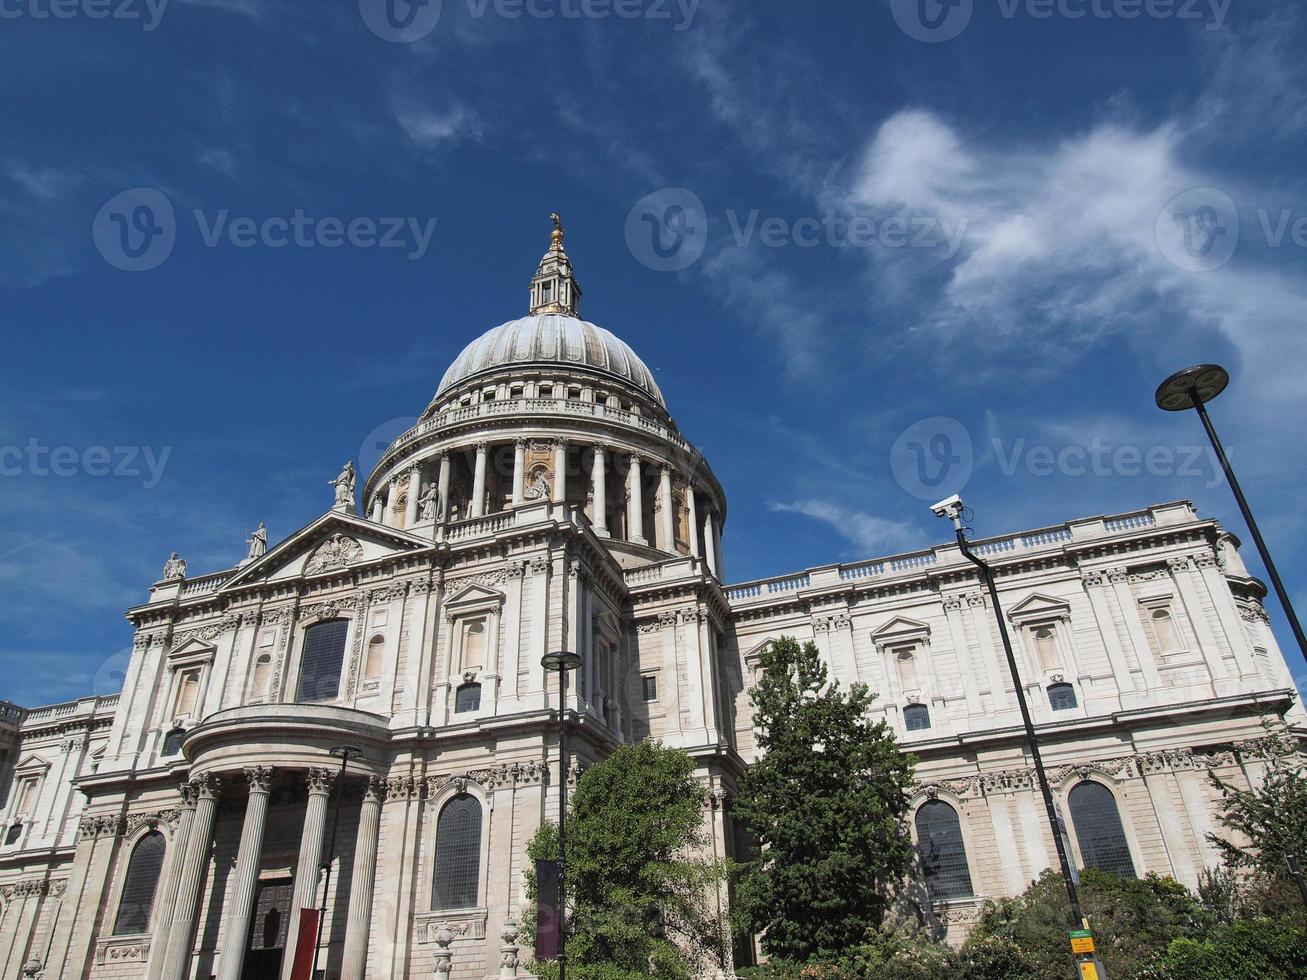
[965,869,1213,980]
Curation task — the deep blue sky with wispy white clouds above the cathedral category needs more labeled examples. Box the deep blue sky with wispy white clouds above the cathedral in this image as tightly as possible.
[0,0,1307,704]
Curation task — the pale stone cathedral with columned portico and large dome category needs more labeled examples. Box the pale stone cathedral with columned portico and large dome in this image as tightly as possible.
[0,220,1303,980]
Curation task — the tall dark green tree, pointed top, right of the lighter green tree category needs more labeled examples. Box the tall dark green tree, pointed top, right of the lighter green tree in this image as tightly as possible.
[733,636,915,962]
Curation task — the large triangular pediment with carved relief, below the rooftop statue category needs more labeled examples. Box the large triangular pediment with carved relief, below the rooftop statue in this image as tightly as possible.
[222,511,433,592]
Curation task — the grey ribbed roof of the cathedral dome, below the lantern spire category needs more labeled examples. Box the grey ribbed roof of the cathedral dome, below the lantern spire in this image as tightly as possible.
[435,314,667,409]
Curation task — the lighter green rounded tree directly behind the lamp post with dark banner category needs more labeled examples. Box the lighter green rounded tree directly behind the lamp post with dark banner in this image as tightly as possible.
[527,742,727,980]
